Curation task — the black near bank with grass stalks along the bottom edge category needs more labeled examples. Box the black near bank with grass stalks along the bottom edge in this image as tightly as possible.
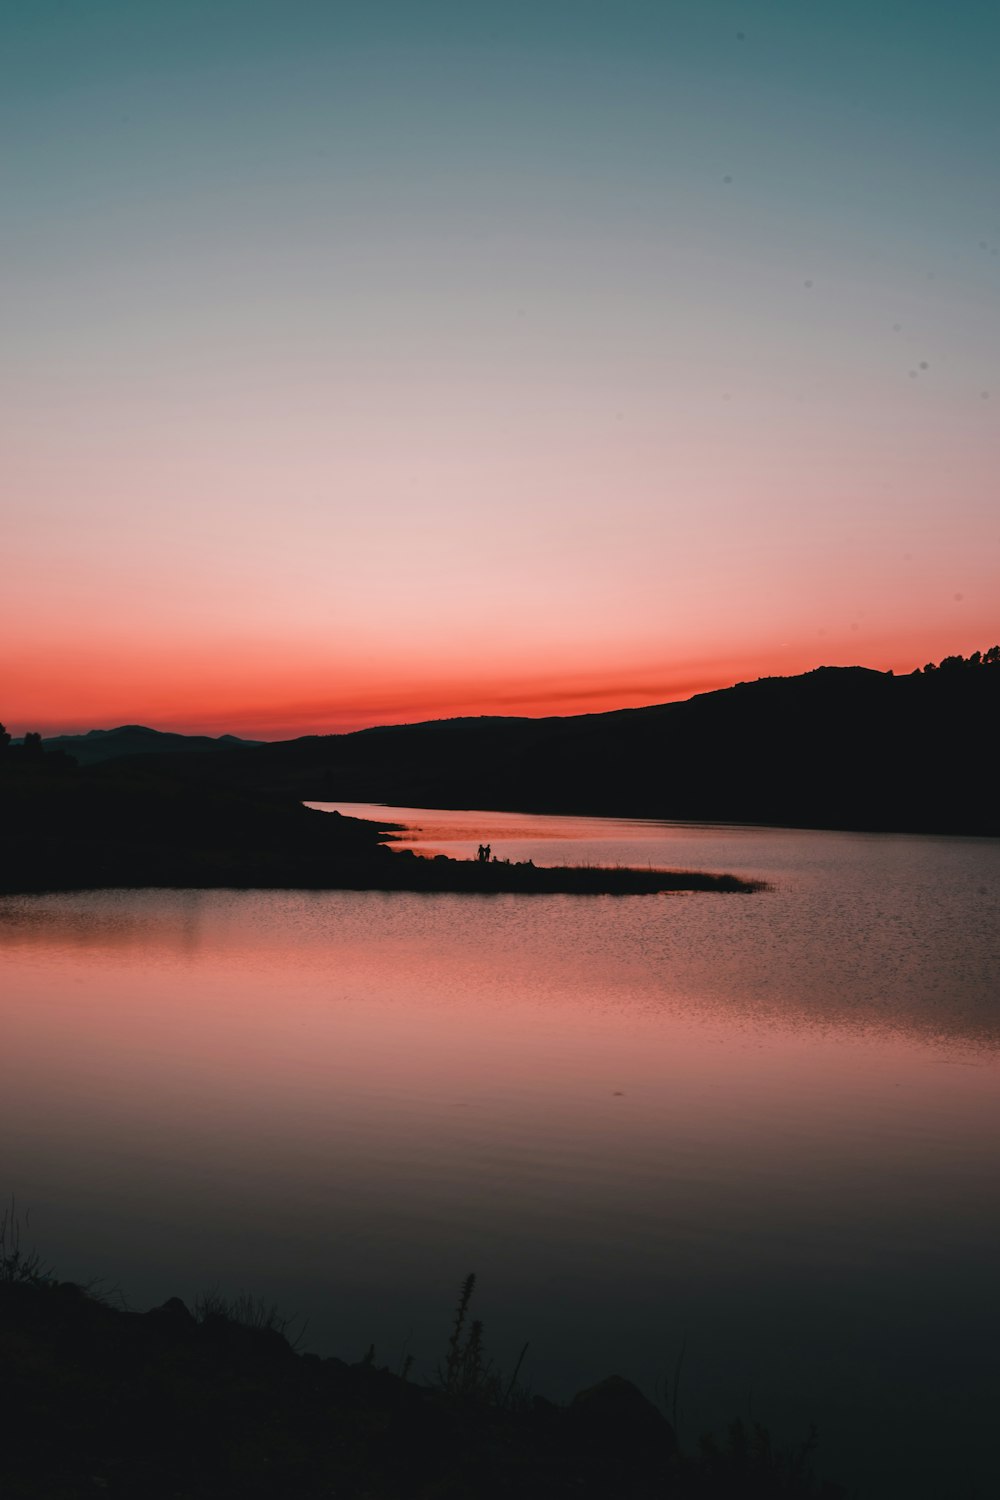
[0,1280,844,1500]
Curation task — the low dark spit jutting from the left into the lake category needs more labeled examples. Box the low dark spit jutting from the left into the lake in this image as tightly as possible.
[0,750,757,896]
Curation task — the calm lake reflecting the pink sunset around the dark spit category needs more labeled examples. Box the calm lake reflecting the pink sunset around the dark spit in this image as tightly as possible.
[0,804,1000,1500]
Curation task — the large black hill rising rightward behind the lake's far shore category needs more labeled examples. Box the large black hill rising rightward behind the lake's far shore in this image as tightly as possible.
[179,662,1000,836]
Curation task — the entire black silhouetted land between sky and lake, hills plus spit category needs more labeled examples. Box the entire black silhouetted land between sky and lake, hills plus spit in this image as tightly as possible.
[0,647,1000,894]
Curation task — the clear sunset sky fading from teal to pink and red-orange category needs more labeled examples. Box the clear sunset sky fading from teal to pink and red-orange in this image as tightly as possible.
[0,0,1000,738]
